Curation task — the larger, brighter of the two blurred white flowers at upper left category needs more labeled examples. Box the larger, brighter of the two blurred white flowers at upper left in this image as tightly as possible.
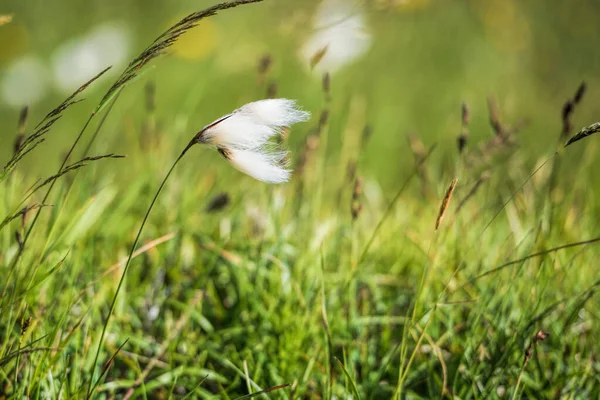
[52,23,130,92]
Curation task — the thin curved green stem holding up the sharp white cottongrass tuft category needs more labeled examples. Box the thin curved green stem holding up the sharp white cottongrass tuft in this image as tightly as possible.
[86,140,196,399]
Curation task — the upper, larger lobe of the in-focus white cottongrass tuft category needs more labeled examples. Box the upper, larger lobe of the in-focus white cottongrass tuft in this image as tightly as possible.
[200,99,310,150]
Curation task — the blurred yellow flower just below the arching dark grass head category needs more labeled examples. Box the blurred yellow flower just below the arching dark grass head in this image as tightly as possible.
[170,20,219,60]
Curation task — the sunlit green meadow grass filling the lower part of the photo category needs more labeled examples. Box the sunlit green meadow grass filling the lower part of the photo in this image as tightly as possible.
[0,1,600,399]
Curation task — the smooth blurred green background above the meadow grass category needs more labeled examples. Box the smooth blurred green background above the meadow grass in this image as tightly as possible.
[0,0,600,190]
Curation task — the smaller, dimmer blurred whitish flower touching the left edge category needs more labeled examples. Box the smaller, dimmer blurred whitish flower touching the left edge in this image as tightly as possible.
[0,55,48,107]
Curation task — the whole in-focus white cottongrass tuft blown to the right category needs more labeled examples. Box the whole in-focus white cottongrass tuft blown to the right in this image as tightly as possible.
[195,99,310,183]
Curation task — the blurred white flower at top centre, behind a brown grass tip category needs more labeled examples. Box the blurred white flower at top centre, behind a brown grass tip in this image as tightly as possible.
[301,0,371,72]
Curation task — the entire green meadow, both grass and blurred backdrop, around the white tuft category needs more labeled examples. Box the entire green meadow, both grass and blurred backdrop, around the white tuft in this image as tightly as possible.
[0,0,600,399]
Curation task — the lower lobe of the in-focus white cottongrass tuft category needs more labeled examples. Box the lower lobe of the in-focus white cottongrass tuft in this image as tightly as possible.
[227,149,292,183]
